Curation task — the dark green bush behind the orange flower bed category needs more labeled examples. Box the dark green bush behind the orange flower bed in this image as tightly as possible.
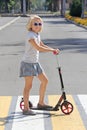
[70,0,82,17]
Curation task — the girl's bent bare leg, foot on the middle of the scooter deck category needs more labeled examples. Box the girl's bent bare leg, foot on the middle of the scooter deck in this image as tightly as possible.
[38,73,48,105]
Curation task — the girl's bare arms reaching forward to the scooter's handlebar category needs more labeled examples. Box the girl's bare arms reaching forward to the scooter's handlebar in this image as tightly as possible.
[29,39,59,53]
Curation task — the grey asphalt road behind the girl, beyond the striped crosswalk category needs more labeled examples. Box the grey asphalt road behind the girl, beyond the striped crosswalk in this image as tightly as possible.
[0,17,87,96]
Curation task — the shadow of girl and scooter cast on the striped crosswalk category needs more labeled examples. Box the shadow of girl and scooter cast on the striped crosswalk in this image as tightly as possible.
[0,112,64,126]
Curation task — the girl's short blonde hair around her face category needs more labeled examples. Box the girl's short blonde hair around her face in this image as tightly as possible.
[26,15,43,31]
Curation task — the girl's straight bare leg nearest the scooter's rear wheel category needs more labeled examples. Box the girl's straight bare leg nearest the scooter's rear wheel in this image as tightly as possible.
[23,76,33,110]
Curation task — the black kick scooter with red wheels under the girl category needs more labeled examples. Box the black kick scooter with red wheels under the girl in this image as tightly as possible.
[20,52,73,115]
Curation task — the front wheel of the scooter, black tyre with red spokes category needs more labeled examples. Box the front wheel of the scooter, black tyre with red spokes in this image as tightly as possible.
[61,101,73,115]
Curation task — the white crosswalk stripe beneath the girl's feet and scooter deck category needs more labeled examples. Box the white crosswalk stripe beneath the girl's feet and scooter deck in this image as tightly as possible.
[12,96,44,130]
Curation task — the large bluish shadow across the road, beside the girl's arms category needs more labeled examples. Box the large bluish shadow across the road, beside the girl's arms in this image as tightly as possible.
[43,38,87,53]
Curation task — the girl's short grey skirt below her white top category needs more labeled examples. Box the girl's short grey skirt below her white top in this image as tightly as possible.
[20,61,43,77]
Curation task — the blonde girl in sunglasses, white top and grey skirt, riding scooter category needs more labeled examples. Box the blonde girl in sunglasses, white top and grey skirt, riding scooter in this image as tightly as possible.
[20,15,59,115]
